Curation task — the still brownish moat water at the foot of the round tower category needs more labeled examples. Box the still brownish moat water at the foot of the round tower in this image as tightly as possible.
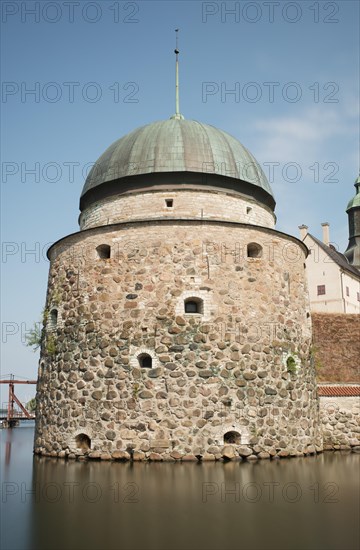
[0,425,360,550]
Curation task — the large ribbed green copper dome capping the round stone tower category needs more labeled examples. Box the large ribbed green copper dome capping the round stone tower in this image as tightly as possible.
[80,117,275,209]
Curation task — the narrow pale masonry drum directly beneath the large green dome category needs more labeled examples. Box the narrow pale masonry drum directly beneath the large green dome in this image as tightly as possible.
[80,189,275,229]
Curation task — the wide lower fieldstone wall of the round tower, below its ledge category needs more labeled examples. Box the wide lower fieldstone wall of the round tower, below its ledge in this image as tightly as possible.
[35,221,322,460]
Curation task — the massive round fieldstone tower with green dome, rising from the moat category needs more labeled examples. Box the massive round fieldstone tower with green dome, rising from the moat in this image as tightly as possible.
[35,115,321,460]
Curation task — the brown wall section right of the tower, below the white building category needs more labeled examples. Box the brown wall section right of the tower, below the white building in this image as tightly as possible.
[311,313,360,383]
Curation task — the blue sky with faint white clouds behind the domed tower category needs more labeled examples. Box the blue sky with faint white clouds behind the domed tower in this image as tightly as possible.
[1,0,359,401]
